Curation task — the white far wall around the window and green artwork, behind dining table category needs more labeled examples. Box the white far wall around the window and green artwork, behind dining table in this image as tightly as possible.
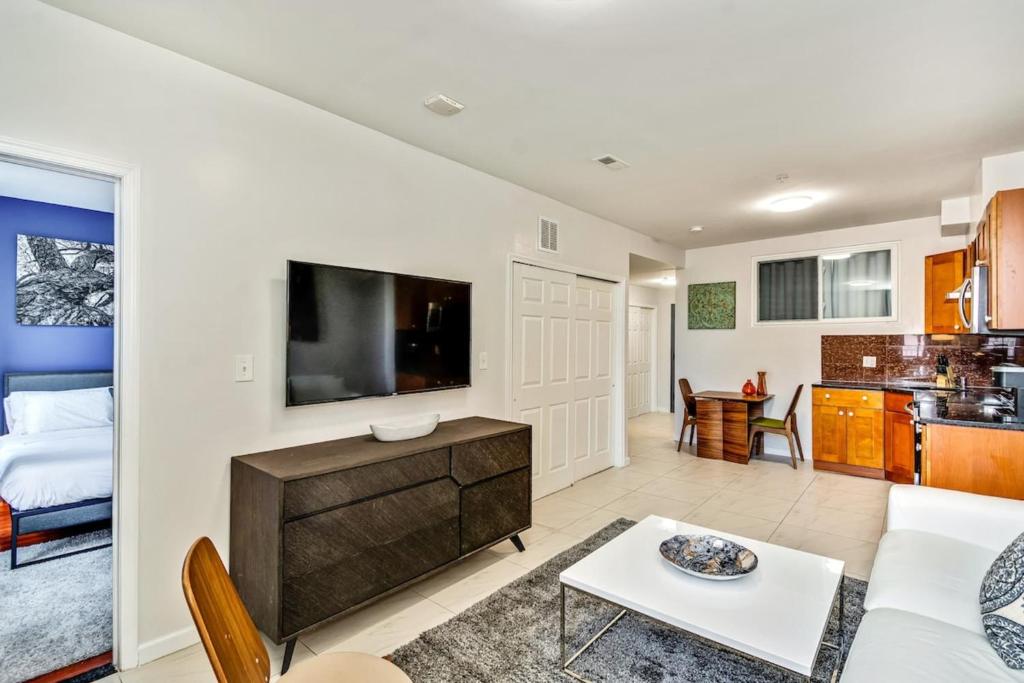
[676,216,967,453]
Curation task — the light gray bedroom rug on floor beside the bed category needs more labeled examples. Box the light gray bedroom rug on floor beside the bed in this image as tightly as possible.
[0,530,114,683]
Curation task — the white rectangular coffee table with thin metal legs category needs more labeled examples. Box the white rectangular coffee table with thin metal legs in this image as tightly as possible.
[559,515,844,681]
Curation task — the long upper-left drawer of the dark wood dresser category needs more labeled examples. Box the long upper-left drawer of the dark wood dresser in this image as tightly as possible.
[285,449,449,519]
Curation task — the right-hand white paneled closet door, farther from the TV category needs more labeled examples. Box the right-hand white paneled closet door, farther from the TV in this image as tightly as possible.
[572,276,612,480]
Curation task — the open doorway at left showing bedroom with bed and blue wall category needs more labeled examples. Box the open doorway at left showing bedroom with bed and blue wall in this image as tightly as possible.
[0,159,117,683]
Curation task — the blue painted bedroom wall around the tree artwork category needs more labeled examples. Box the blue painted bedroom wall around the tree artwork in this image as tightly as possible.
[0,197,114,431]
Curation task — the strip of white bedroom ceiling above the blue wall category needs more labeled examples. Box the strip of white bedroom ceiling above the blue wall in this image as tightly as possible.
[0,161,114,213]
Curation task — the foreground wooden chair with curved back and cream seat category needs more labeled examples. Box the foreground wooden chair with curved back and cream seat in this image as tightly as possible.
[181,537,412,683]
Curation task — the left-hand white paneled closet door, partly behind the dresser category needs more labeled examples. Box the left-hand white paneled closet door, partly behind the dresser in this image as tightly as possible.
[512,263,577,499]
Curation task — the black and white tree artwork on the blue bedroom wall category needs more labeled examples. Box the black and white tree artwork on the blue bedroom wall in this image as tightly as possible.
[14,234,114,327]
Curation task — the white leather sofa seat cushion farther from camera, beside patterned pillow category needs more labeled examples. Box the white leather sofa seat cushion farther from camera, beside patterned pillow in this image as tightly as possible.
[864,529,998,635]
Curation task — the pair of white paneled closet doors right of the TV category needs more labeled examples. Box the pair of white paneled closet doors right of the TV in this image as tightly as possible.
[512,263,613,499]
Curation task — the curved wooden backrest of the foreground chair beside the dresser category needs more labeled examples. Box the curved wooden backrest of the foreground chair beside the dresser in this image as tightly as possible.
[181,537,270,683]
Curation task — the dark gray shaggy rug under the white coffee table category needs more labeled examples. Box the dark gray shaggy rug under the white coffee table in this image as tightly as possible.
[391,519,867,683]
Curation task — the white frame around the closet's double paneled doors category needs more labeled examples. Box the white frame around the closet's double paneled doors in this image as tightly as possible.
[505,253,630,473]
